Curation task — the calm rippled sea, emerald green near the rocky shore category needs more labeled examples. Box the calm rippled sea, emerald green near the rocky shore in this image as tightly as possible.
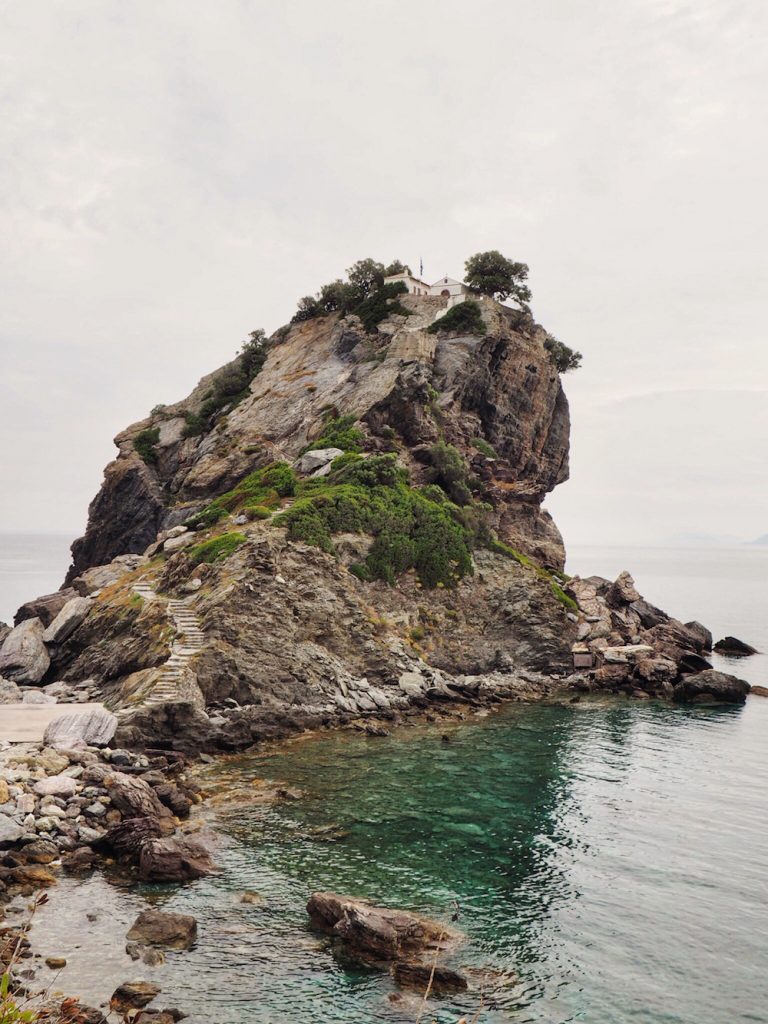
[0,539,768,1024]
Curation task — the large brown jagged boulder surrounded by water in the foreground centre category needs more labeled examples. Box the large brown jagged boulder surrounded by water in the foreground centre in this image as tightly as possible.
[306,892,461,964]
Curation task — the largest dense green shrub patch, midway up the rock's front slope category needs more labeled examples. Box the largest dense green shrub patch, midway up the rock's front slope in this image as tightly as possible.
[274,455,473,587]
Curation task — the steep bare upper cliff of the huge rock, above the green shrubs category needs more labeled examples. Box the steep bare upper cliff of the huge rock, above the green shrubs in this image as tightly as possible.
[68,296,569,580]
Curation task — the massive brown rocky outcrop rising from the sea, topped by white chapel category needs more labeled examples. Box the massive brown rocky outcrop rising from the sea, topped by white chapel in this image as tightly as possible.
[0,288,753,753]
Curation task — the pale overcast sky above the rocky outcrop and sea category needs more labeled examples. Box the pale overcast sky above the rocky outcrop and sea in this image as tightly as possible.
[0,0,768,544]
